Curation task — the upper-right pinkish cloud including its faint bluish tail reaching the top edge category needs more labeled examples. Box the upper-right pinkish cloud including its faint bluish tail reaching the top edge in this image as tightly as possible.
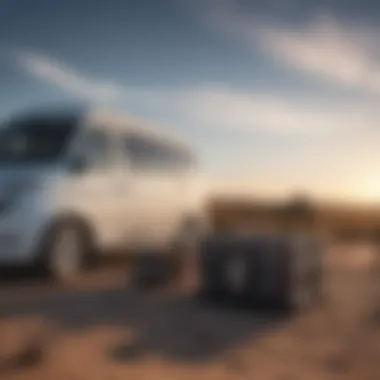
[202,0,380,94]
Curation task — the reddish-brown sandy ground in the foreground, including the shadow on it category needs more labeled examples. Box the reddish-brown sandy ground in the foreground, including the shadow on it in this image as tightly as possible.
[0,246,380,380]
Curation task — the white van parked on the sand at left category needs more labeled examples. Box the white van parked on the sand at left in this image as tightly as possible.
[0,109,207,279]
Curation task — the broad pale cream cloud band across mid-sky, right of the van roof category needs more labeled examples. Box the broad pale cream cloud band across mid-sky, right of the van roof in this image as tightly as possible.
[177,87,380,137]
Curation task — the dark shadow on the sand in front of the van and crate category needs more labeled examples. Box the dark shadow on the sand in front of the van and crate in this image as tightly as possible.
[0,272,283,362]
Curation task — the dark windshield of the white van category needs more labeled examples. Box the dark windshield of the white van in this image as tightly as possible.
[0,117,76,163]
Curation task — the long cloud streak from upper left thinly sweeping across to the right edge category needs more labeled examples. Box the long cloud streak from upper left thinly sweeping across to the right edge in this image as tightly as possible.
[12,52,380,137]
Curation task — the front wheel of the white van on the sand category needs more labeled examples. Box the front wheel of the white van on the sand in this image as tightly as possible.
[41,220,89,284]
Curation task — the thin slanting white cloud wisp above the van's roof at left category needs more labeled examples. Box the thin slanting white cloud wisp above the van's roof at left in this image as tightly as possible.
[14,51,122,102]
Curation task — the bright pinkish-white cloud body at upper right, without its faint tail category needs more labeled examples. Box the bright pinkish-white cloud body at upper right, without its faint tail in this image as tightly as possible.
[255,17,380,94]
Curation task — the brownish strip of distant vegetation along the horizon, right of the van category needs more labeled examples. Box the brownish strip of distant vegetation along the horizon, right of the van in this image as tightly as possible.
[209,195,380,240]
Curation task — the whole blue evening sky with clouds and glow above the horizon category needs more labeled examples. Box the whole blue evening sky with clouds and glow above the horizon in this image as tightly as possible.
[0,0,380,202]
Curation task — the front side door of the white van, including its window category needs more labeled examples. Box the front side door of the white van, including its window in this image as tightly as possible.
[62,127,122,250]
